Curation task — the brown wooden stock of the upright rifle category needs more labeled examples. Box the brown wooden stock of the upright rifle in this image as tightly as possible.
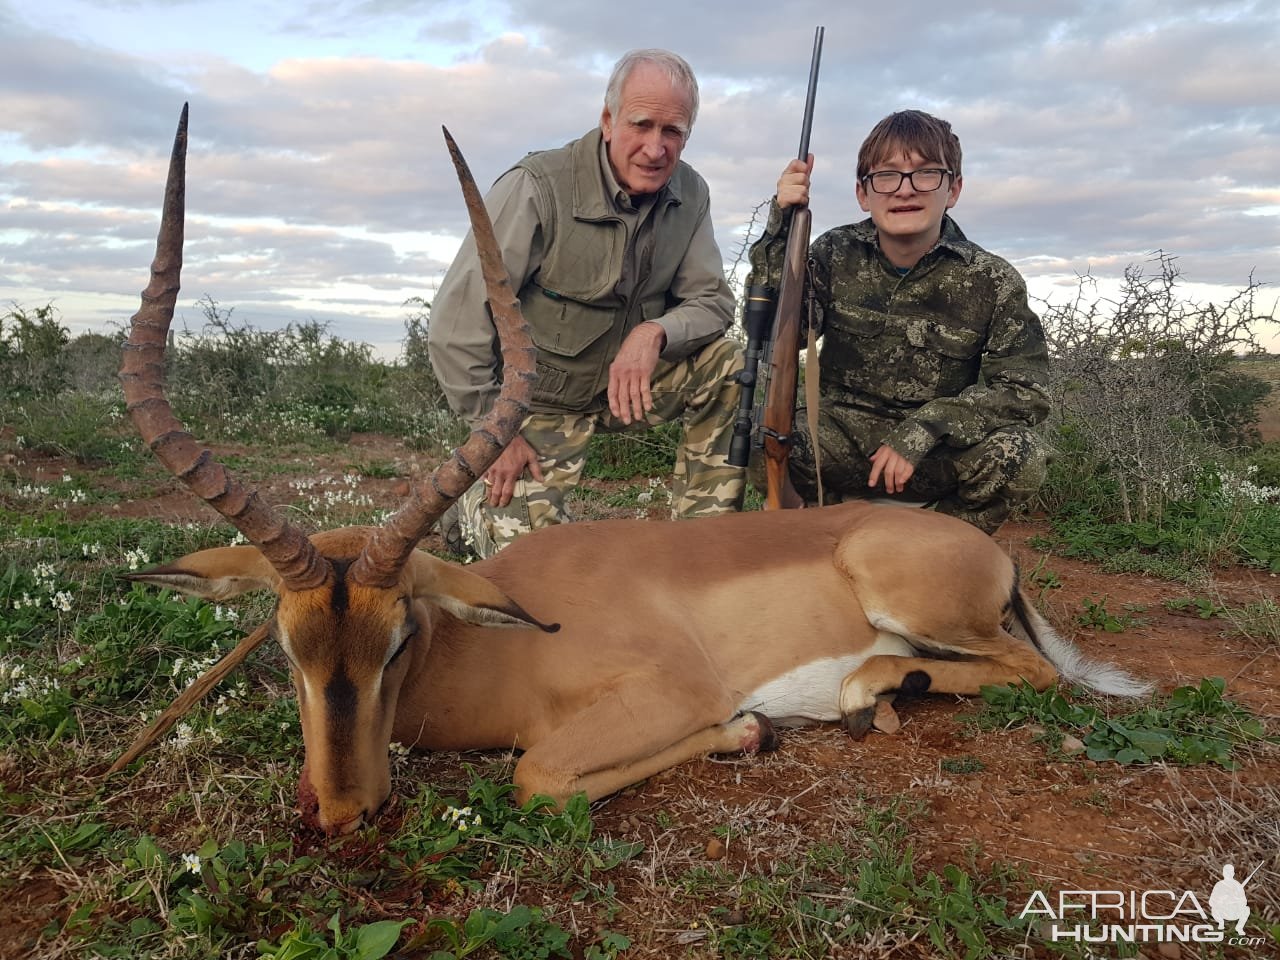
[762,206,813,509]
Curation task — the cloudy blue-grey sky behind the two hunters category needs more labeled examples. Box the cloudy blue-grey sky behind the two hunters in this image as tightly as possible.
[0,0,1280,355]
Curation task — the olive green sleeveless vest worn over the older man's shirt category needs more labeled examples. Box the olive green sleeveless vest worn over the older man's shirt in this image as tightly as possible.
[512,129,709,412]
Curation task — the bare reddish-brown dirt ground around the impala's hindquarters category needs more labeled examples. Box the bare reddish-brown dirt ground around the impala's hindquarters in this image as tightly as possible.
[5,438,1280,957]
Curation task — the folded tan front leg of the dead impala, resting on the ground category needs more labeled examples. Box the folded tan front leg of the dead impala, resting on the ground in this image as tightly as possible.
[515,692,777,806]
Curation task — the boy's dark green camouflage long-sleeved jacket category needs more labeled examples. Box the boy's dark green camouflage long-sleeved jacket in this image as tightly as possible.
[748,202,1048,463]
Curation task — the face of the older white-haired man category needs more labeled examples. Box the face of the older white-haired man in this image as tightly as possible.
[600,63,690,196]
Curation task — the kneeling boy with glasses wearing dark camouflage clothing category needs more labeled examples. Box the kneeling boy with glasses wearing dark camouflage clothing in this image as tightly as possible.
[748,110,1048,534]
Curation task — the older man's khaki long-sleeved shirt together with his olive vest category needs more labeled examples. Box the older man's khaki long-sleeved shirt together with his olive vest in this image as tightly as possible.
[428,129,733,424]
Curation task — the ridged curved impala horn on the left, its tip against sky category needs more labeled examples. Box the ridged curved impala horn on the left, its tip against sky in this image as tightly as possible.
[120,104,330,590]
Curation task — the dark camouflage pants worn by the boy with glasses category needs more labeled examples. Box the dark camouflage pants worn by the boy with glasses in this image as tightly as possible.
[791,404,1050,534]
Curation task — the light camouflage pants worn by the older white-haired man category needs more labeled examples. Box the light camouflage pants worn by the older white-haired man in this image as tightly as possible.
[458,339,745,559]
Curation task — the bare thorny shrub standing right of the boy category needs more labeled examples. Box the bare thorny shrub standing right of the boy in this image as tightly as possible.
[1044,252,1270,522]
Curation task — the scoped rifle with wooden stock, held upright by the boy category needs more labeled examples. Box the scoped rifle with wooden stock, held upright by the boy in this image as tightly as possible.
[728,27,824,509]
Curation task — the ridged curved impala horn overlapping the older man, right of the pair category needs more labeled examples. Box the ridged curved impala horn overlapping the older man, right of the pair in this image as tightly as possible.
[351,129,536,588]
